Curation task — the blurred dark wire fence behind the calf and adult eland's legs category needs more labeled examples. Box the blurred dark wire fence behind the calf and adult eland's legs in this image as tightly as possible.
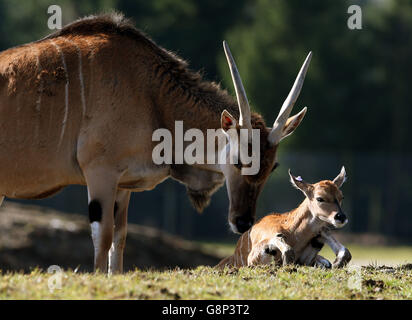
[9,152,412,242]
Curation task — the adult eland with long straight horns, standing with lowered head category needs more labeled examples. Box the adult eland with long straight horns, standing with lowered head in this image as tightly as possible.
[0,14,311,272]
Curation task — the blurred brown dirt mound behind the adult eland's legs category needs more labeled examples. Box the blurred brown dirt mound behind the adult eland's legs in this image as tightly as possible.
[0,202,219,272]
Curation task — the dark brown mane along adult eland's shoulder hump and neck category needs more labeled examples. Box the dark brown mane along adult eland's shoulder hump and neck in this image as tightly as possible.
[44,14,239,127]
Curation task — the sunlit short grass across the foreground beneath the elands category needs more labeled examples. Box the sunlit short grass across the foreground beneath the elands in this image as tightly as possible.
[0,243,412,300]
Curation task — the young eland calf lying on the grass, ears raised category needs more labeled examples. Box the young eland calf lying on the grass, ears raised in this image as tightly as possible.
[218,167,352,268]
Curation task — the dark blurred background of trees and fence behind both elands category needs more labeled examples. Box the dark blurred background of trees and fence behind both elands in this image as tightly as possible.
[0,0,412,242]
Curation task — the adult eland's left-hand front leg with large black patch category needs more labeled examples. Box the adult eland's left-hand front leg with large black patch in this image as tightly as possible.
[84,168,118,272]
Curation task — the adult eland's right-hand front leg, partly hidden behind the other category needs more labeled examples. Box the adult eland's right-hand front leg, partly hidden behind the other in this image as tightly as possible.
[109,190,130,274]
